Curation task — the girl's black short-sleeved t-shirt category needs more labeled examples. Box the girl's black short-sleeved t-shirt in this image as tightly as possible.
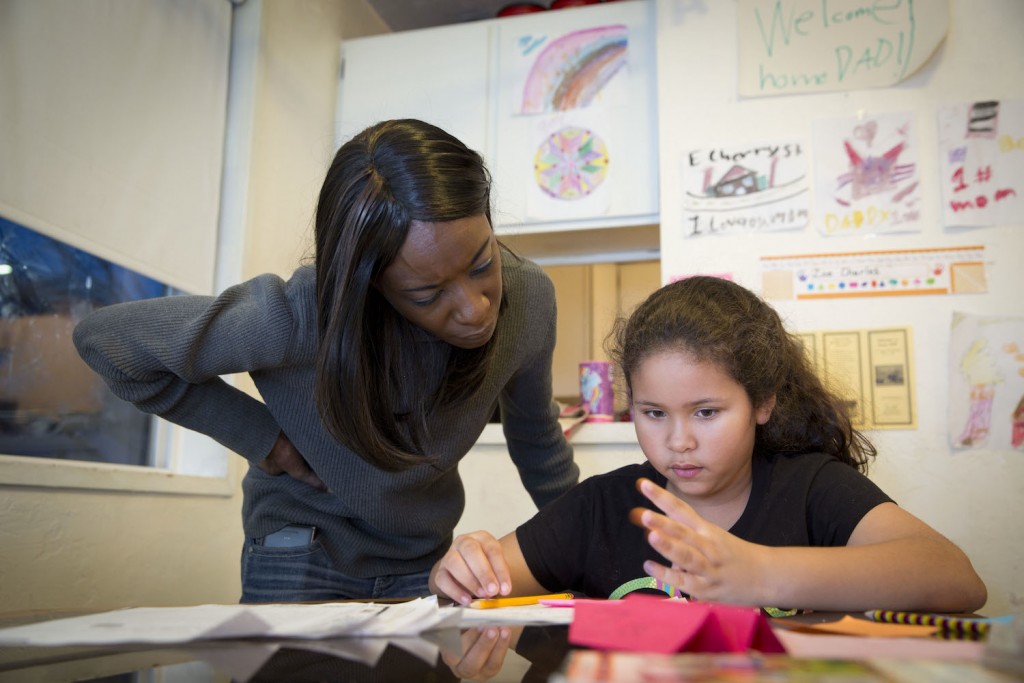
[516,454,892,598]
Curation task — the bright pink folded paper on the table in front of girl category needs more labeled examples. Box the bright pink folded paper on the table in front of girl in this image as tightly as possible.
[569,594,785,654]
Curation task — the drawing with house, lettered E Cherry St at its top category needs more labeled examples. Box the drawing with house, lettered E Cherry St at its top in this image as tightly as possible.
[681,141,809,237]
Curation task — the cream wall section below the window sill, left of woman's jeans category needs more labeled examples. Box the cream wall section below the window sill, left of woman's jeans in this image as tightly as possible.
[0,475,241,614]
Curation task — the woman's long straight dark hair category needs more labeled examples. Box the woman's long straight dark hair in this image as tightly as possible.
[315,119,493,471]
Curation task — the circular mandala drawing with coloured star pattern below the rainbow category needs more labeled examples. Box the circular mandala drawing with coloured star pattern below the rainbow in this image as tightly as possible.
[534,126,608,200]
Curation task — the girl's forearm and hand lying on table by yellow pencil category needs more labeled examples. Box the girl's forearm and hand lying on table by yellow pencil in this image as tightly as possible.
[430,531,547,605]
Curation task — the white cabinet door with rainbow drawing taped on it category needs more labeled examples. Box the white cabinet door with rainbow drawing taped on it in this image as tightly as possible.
[488,2,658,230]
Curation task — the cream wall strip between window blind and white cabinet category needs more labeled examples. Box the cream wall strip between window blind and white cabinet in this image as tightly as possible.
[243,0,388,276]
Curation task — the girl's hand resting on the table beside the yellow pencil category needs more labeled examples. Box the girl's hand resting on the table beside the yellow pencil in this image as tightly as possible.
[430,531,512,605]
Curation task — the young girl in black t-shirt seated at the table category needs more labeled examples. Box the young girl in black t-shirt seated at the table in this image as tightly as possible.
[430,276,987,612]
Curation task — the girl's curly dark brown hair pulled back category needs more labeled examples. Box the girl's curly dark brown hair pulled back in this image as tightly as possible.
[611,276,876,472]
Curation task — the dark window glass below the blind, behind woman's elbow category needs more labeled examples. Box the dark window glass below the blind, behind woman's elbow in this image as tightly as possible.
[0,217,176,466]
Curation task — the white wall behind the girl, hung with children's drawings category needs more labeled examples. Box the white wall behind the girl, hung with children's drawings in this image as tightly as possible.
[657,0,1024,614]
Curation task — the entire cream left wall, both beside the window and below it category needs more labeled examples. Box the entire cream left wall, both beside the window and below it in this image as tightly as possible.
[0,0,386,614]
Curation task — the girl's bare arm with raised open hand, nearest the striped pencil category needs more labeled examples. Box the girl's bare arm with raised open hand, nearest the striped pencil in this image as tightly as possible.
[635,480,987,612]
